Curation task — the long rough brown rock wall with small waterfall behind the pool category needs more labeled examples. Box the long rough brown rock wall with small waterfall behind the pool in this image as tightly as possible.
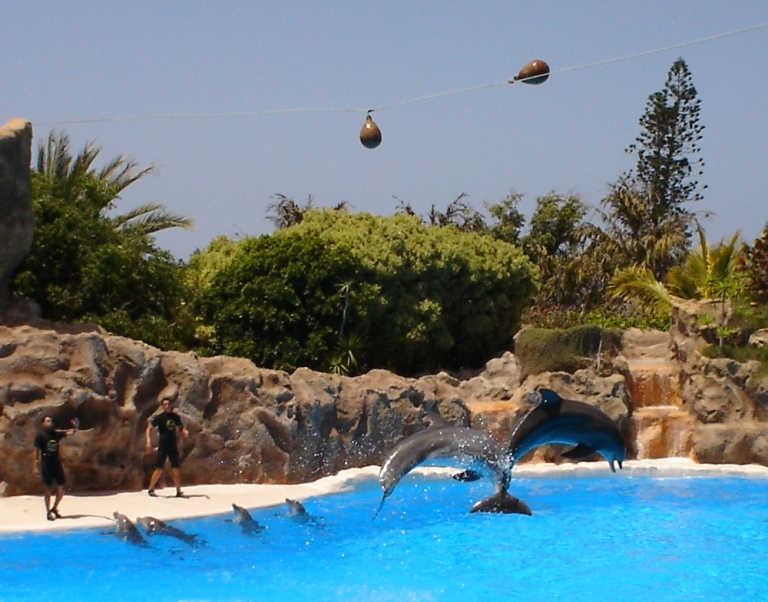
[0,319,768,495]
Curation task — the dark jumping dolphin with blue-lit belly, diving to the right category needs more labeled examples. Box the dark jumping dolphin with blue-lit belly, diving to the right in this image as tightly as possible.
[508,389,627,472]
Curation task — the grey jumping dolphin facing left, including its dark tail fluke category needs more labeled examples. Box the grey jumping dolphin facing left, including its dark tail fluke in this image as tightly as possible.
[374,426,531,518]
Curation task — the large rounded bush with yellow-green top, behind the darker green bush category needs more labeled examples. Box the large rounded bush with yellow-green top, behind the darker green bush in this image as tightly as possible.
[284,211,537,373]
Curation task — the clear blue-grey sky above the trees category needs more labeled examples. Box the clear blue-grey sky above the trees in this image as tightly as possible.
[6,0,768,259]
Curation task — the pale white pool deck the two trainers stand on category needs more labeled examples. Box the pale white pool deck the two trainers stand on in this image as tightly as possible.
[0,458,768,533]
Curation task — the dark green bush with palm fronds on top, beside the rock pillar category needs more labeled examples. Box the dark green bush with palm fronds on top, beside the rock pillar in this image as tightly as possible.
[12,132,195,348]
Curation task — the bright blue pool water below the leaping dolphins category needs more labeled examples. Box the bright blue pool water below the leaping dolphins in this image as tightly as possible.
[0,475,768,602]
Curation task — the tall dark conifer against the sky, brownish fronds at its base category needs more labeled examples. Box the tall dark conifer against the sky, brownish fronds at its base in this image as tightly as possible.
[589,59,704,280]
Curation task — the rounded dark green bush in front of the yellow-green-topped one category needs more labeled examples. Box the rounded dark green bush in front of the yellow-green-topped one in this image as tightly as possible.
[195,229,368,370]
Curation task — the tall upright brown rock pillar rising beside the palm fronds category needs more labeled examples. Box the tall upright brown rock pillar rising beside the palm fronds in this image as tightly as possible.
[0,119,34,315]
